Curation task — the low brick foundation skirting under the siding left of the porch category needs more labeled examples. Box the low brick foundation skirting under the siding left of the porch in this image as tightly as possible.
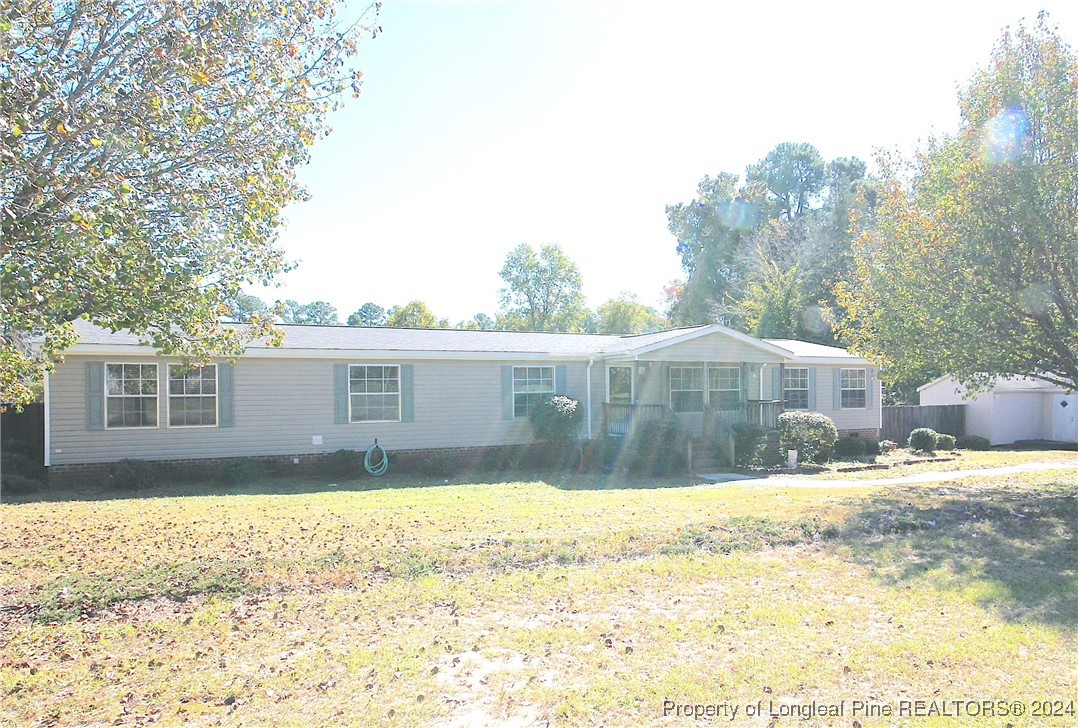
[47,445,541,487]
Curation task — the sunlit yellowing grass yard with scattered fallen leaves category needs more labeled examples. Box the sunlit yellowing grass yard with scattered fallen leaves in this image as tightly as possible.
[0,453,1078,727]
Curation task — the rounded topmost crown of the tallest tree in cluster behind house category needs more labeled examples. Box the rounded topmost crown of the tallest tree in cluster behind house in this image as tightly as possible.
[745,141,828,220]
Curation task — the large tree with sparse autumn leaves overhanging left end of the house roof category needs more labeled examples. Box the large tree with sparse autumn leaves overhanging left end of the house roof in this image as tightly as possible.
[0,0,376,403]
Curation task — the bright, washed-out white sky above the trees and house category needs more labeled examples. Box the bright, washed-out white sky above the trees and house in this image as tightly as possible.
[251,0,1078,324]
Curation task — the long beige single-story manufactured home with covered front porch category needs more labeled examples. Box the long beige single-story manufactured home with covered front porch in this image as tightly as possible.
[45,321,880,477]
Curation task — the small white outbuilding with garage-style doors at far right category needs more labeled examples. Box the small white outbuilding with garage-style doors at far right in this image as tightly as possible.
[917,376,1078,445]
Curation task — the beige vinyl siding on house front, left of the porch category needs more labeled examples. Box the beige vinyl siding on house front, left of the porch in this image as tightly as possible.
[50,355,590,465]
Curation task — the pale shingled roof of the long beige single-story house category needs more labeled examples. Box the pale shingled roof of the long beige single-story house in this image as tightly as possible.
[65,320,856,359]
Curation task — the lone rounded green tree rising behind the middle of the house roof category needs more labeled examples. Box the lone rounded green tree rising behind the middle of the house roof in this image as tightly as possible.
[499,244,588,332]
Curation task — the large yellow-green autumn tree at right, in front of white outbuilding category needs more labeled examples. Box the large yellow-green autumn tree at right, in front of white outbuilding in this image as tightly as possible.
[839,15,1078,388]
